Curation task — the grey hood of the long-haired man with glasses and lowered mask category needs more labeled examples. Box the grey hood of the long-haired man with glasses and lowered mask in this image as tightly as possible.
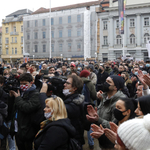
[64,94,84,105]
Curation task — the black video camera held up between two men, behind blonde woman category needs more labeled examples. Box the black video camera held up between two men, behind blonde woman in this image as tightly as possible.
[35,75,67,99]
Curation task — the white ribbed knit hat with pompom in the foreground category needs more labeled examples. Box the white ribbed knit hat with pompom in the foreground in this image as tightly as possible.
[117,114,150,150]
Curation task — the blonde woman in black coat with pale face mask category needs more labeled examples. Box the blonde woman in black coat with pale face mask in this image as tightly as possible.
[34,95,76,150]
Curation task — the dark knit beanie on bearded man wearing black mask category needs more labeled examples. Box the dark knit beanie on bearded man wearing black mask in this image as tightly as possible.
[110,75,124,91]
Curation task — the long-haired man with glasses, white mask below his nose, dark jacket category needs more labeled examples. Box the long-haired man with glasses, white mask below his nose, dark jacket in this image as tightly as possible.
[63,75,85,147]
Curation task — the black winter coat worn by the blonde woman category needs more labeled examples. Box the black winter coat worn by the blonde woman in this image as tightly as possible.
[34,118,76,150]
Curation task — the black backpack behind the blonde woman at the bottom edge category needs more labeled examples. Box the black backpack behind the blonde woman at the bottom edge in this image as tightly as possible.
[68,138,81,150]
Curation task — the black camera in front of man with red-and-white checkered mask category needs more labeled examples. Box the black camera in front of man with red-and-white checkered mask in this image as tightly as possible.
[3,75,20,93]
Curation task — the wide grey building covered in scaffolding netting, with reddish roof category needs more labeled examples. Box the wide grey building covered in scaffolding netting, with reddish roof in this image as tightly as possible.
[23,1,99,60]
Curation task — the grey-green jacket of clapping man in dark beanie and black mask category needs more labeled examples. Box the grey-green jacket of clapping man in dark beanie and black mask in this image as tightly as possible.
[97,91,126,128]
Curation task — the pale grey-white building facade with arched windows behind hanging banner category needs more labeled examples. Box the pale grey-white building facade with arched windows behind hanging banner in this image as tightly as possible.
[97,0,150,61]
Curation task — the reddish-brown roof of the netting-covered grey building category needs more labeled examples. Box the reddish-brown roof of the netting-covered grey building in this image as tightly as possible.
[32,1,100,15]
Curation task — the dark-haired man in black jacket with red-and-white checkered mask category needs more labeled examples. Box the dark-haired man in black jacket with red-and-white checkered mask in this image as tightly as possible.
[10,73,44,150]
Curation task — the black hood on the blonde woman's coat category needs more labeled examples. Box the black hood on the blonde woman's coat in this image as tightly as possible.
[45,118,76,138]
